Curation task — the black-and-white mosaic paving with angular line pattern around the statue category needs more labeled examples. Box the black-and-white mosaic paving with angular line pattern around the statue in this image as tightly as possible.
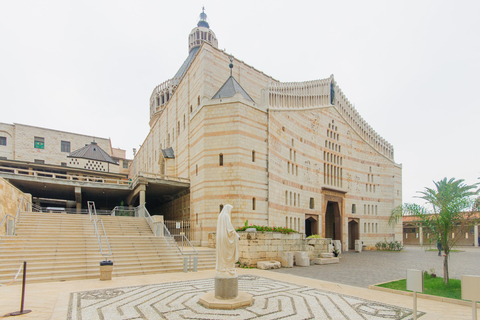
[67,275,424,320]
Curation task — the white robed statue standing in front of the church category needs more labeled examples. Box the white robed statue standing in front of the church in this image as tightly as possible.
[216,204,240,277]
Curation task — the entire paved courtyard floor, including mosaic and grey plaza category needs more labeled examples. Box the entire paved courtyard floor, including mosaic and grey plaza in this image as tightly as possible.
[0,247,480,319]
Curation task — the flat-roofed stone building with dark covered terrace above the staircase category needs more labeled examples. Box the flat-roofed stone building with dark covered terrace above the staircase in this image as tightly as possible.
[0,123,133,209]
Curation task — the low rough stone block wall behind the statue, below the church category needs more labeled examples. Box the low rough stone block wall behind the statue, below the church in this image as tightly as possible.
[208,231,332,267]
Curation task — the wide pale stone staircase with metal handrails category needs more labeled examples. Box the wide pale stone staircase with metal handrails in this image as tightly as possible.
[0,212,215,284]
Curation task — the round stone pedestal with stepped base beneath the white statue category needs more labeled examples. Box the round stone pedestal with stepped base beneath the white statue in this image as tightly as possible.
[198,276,253,310]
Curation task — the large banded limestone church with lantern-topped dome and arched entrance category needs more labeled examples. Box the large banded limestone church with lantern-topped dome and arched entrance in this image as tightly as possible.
[132,12,402,249]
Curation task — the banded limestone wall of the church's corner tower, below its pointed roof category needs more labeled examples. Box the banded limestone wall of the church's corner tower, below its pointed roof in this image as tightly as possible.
[190,97,268,245]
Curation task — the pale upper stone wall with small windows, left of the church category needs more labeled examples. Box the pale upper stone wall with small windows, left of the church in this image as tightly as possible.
[14,123,112,165]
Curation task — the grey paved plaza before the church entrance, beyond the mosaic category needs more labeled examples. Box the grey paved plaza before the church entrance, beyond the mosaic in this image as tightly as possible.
[275,246,480,288]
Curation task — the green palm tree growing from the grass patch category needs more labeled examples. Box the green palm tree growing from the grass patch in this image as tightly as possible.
[389,178,480,285]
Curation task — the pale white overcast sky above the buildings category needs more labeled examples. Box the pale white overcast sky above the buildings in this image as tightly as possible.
[0,0,480,202]
